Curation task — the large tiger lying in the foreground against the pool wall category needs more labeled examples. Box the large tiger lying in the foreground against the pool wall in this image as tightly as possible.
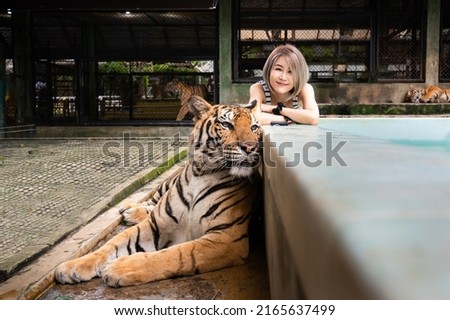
[54,95,262,287]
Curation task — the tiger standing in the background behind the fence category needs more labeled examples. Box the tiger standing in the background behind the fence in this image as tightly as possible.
[165,79,208,121]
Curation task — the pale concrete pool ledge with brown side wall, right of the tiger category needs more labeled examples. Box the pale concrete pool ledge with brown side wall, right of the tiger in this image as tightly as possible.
[264,119,450,299]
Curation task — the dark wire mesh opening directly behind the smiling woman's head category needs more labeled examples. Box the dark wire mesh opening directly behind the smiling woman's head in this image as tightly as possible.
[234,0,426,82]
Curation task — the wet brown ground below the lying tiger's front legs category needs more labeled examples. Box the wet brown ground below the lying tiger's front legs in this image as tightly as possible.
[41,219,270,300]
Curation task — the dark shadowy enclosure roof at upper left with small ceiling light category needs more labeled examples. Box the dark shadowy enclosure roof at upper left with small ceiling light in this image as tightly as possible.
[0,0,217,60]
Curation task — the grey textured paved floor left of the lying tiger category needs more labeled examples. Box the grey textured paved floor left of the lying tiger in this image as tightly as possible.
[0,136,187,282]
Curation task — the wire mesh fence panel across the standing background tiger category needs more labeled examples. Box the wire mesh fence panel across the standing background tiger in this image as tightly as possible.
[98,67,214,120]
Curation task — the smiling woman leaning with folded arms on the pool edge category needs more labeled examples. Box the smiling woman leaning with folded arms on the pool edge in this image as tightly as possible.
[250,44,319,125]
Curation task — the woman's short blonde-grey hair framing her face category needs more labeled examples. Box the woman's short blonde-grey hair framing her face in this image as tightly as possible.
[263,44,309,100]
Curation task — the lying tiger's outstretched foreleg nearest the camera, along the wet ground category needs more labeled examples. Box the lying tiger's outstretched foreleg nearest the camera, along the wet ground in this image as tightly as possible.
[102,233,249,287]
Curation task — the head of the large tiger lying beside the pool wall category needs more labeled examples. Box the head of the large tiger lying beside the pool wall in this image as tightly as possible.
[188,95,262,177]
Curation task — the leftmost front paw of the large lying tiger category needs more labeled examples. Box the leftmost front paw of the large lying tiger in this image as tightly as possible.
[55,256,99,284]
